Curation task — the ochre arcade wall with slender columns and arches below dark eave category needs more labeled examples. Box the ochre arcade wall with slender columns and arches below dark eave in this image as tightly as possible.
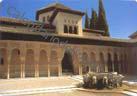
[0,40,137,78]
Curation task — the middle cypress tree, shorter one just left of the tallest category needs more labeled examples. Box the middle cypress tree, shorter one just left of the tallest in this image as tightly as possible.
[90,10,98,29]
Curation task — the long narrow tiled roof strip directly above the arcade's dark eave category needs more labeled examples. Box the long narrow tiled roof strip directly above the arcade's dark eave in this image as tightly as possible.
[0,26,137,43]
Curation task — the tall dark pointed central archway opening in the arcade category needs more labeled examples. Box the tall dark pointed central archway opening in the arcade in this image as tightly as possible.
[62,51,73,74]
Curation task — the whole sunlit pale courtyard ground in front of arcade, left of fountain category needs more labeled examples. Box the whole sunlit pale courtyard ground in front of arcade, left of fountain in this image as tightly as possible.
[0,76,137,96]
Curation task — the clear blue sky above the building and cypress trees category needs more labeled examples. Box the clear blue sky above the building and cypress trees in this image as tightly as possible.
[0,0,137,38]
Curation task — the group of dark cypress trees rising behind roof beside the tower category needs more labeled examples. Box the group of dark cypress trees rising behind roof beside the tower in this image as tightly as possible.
[85,0,110,36]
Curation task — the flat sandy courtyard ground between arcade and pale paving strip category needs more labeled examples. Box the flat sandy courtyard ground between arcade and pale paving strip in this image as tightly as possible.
[0,77,78,91]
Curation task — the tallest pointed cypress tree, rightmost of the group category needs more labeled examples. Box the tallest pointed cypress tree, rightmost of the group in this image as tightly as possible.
[97,0,110,36]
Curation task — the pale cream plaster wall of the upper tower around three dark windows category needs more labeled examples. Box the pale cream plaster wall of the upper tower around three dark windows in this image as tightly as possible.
[53,12,83,36]
